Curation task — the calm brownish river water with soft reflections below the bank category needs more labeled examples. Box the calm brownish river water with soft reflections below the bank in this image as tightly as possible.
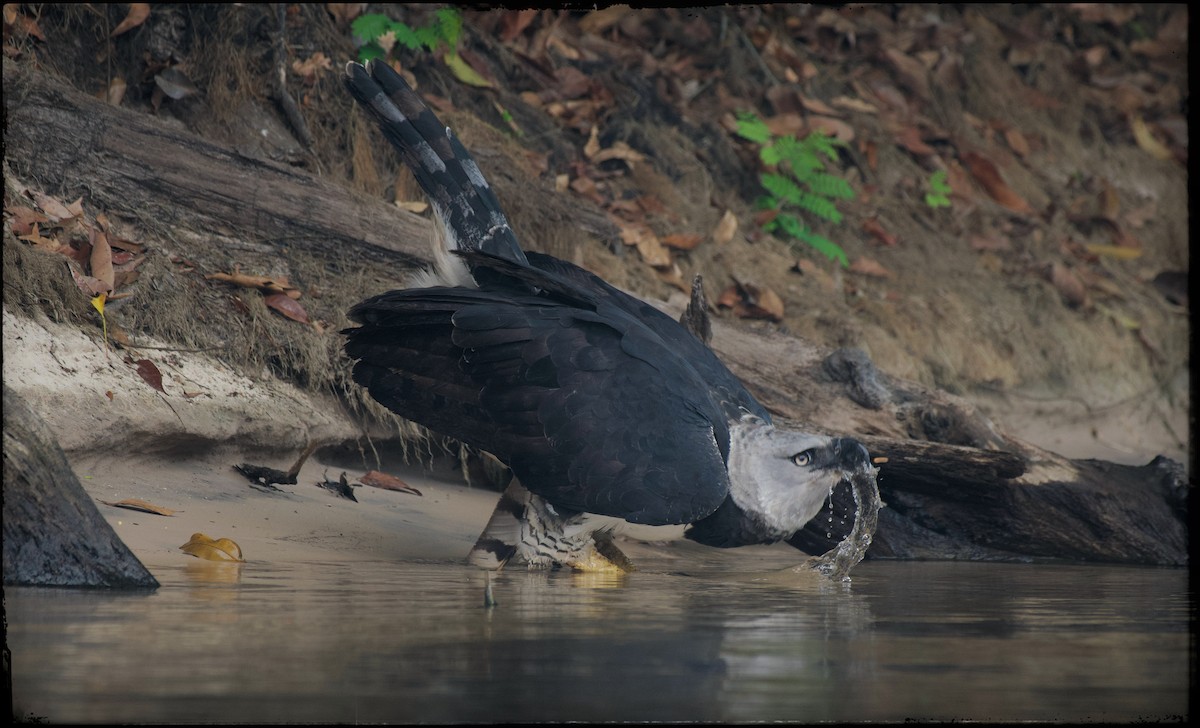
[5,559,1193,723]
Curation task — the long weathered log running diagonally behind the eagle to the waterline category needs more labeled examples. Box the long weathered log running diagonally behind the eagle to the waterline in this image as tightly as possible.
[4,64,1188,565]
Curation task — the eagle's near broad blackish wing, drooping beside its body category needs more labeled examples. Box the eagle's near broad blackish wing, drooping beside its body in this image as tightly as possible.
[346,260,728,524]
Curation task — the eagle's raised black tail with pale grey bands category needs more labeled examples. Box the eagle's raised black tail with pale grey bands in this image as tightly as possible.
[343,61,529,271]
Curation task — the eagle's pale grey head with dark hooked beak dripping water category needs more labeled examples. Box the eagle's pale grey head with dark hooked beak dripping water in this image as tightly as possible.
[728,415,871,539]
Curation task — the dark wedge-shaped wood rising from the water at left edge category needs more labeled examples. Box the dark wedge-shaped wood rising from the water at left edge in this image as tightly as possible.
[4,385,158,588]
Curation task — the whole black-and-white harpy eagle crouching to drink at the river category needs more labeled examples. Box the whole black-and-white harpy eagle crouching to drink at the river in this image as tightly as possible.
[343,62,878,570]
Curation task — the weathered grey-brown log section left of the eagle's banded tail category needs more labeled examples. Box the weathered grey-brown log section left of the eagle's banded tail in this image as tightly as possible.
[4,62,432,271]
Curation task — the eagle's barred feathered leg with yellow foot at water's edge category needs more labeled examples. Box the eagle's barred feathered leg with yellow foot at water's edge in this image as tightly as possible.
[467,480,634,572]
